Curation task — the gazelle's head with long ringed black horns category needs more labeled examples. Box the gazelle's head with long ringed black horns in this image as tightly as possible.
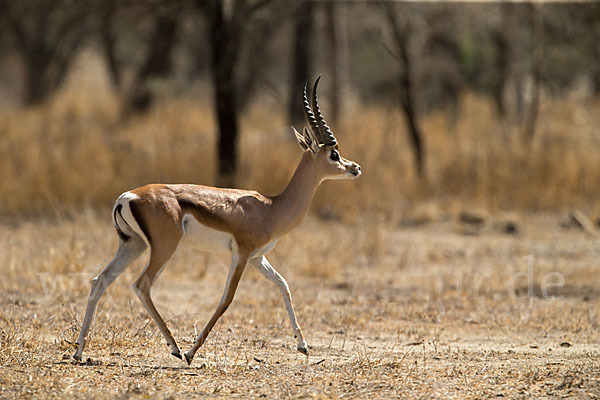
[292,76,361,179]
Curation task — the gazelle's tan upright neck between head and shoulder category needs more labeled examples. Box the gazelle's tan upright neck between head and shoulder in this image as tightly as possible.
[272,151,322,236]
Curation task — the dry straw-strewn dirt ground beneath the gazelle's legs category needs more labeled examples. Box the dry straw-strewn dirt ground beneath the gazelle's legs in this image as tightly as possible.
[0,212,600,399]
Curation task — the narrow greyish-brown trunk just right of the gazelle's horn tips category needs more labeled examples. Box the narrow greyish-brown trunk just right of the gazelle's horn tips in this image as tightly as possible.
[325,2,341,122]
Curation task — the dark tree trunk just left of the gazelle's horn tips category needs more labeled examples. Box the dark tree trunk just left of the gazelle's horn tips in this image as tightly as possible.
[288,0,313,125]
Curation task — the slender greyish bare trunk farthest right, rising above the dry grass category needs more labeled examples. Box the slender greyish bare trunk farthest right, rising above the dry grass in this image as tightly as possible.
[523,4,544,144]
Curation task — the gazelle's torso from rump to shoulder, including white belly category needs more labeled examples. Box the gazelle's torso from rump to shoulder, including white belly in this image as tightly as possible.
[129,184,271,253]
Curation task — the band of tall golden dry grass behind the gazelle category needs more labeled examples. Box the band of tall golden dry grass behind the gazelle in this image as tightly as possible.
[0,77,600,220]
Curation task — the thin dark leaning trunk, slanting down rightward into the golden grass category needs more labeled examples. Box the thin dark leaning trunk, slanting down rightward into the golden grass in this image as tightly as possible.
[386,4,425,179]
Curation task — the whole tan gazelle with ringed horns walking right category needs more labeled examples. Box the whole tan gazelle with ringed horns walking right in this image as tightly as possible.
[73,77,361,364]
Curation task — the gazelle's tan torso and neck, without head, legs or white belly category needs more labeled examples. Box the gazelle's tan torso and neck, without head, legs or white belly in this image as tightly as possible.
[130,152,320,252]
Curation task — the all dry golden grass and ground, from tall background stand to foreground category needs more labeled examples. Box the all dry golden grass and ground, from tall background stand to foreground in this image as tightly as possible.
[0,57,600,398]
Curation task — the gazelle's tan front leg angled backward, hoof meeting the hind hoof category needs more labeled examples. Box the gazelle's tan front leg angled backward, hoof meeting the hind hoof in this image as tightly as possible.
[184,253,248,365]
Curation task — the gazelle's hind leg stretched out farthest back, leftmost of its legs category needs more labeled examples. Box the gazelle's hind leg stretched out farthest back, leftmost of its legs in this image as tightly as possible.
[73,236,146,361]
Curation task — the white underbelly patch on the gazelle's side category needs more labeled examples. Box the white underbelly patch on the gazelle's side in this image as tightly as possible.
[181,214,237,253]
